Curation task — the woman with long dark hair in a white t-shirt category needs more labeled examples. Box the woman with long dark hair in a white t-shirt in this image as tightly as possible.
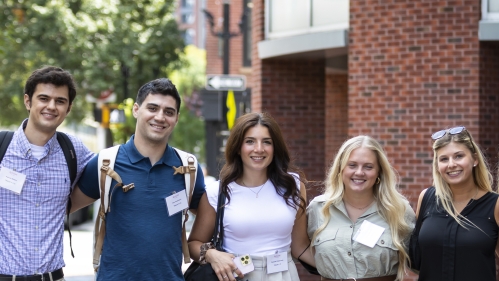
[189,113,313,281]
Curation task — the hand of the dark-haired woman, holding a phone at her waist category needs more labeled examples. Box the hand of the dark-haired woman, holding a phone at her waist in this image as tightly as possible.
[206,249,244,281]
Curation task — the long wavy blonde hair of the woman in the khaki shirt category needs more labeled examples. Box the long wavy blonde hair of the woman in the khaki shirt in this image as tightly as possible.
[312,136,411,280]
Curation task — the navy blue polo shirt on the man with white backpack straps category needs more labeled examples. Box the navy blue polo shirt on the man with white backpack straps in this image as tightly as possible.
[78,137,205,281]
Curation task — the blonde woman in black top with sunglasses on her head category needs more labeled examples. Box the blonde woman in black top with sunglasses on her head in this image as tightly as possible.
[416,127,499,281]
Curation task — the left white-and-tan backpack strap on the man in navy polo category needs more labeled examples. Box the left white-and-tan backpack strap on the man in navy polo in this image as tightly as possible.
[93,145,122,272]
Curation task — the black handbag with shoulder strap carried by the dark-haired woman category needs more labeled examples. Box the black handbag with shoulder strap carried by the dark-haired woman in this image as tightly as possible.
[184,186,225,281]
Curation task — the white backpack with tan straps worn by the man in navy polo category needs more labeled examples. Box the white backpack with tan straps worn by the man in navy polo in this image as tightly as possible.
[93,145,198,272]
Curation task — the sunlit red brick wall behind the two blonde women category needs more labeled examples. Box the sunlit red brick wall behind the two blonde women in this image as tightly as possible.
[348,0,480,211]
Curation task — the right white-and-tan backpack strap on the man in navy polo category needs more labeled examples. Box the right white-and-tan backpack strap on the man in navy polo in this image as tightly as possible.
[173,148,198,263]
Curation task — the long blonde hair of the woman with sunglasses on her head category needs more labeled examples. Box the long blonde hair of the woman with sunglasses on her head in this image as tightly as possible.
[433,129,494,226]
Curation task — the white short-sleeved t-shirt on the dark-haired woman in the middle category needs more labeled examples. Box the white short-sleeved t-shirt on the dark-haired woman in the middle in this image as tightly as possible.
[206,174,300,256]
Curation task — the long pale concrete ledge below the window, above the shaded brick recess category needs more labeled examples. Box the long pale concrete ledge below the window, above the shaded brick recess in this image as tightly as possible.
[258,29,348,59]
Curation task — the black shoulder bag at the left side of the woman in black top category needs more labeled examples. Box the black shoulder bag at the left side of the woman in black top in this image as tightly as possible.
[409,187,435,271]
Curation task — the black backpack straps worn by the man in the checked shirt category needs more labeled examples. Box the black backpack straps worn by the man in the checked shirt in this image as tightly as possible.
[0,131,78,258]
